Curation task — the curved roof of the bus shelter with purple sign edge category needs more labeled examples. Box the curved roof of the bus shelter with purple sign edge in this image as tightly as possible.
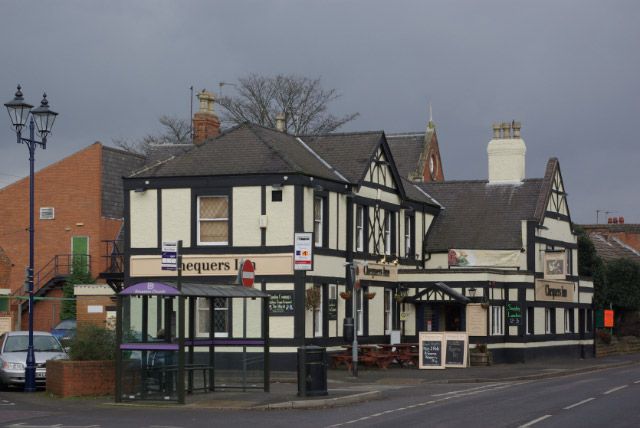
[119,282,269,299]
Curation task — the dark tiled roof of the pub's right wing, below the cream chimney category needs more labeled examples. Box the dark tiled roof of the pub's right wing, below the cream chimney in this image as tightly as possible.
[417,179,543,252]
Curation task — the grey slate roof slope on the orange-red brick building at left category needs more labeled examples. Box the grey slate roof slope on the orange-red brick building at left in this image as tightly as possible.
[102,146,145,218]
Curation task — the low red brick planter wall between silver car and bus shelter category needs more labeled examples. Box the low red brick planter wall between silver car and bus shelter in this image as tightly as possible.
[47,360,116,397]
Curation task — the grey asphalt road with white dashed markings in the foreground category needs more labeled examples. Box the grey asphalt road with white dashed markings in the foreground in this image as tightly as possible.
[0,364,640,428]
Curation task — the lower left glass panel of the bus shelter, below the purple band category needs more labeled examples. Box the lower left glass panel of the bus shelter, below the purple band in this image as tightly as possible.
[121,350,178,401]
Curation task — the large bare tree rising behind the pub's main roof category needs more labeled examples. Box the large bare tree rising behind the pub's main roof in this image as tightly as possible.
[216,74,359,135]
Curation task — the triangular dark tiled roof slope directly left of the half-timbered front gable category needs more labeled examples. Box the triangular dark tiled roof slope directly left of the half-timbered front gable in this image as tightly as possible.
[300,131,384,184]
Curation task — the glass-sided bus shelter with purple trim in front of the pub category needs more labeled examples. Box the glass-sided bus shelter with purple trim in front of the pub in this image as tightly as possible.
[115,282,269,404]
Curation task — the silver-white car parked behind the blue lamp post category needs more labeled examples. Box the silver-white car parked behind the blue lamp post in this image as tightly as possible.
[0,331,67,388]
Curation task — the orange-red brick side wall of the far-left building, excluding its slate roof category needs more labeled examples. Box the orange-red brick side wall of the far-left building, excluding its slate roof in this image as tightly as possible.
[0,143,122,330]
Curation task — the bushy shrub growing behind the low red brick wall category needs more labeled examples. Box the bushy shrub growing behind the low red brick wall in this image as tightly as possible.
[68,323,116,361]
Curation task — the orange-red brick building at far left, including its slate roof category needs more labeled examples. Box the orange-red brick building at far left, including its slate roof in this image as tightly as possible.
[0,142,145,331]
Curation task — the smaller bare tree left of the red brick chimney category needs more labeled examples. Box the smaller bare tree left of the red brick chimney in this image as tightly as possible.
[113,115,191,154]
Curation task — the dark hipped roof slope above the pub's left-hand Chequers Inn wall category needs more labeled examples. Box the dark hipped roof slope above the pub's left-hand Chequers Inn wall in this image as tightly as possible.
[133,123,343,181]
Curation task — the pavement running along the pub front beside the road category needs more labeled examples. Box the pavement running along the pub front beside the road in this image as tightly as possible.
[107,353,640,410]
